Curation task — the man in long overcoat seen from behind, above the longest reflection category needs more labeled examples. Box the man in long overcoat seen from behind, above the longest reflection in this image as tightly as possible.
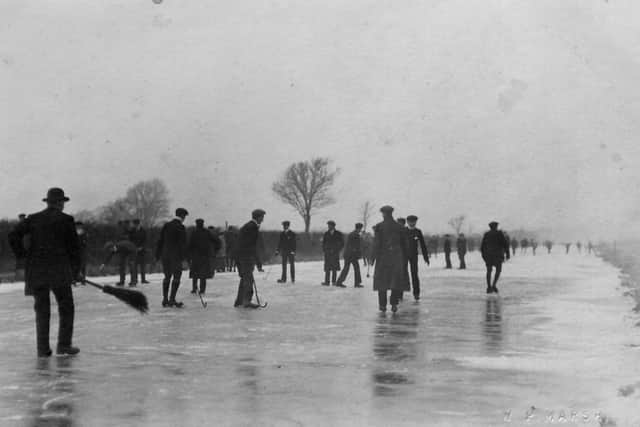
[373,206,410,313]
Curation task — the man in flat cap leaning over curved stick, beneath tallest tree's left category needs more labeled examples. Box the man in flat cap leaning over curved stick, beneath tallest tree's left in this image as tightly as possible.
[233,209,266,308]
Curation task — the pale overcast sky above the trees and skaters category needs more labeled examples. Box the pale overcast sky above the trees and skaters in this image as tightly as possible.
[0,0,640,238]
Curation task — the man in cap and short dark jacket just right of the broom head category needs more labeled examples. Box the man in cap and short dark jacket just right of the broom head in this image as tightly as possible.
[156,208,189,308]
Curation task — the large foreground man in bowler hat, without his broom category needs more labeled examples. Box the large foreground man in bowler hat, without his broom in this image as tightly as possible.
[9,188,84,357]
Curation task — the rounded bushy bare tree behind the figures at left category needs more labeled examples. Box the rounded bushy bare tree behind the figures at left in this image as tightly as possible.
[125,178,169,227]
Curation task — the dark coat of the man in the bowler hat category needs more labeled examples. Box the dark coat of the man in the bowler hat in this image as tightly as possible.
[9,208,81,295]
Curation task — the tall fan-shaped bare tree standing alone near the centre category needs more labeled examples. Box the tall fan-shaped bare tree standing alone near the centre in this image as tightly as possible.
[271,157,340,233]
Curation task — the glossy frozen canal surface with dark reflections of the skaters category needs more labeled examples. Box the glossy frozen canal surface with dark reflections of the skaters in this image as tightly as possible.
[0,253,640,427]
